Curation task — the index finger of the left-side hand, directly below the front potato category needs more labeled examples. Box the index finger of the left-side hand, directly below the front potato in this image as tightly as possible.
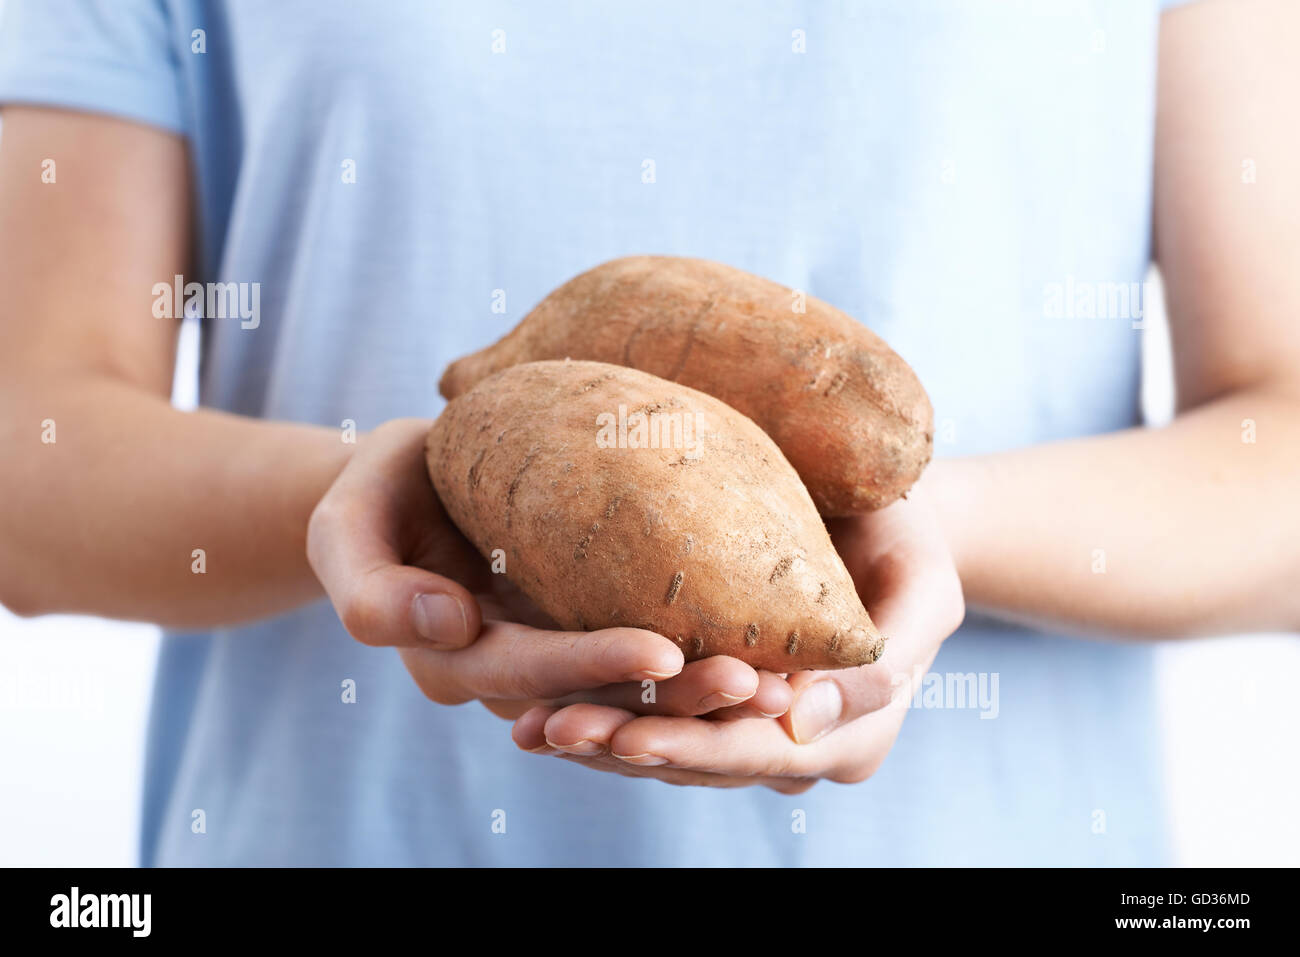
[399,622,684,705]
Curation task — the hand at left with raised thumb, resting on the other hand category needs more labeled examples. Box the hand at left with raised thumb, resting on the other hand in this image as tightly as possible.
[307,419,792,728]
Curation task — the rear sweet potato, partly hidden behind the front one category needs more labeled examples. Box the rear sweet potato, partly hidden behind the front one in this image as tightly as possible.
[439,256,933,516]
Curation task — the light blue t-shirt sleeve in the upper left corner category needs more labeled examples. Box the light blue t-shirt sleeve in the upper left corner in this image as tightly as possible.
[0,0,189,134]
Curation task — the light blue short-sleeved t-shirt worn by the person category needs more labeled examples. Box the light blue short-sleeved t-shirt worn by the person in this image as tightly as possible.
[0,0,1196,865]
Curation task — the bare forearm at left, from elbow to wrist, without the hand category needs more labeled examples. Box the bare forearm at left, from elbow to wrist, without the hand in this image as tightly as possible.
[0,376,354,628]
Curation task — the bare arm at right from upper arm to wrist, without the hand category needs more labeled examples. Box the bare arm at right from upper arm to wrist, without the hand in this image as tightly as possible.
[924,0,1300,636]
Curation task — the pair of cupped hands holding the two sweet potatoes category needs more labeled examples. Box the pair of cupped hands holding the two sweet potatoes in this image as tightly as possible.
[307,419,965,794]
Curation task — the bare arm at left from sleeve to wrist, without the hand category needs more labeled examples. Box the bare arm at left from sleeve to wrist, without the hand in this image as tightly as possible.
[0,108,352,627]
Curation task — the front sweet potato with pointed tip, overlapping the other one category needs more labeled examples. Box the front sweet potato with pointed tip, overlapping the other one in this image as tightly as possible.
[426,361,884,672]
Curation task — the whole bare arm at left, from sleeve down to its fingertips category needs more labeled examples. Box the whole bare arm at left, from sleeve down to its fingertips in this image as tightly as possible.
[0,109,769,714]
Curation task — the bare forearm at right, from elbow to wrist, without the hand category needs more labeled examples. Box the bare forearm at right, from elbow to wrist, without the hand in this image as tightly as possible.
[923,390,1300,637]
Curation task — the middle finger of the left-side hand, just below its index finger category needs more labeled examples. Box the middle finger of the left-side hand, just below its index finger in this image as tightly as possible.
[556,655,761,715]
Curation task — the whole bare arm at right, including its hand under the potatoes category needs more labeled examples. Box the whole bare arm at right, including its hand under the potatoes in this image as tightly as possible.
[512,0,1300,793]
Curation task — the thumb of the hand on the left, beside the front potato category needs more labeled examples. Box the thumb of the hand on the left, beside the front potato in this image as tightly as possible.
[307,502,482,649]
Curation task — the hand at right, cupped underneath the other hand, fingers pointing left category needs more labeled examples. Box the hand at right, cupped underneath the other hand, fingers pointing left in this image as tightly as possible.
[512,492,965,794]
